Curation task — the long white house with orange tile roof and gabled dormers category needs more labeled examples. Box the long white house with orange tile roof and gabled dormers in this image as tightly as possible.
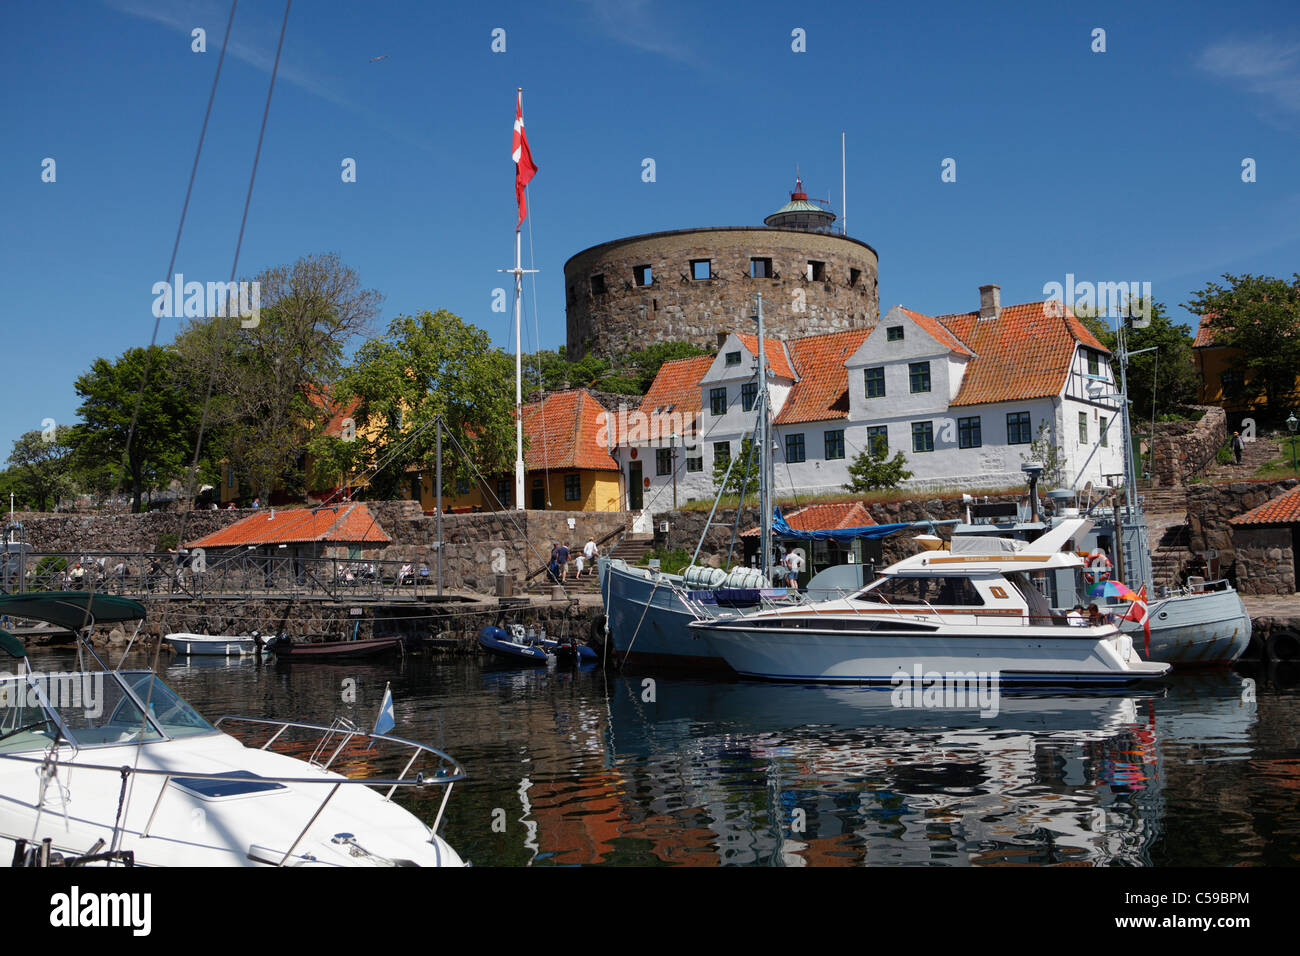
[614,286,1123,515]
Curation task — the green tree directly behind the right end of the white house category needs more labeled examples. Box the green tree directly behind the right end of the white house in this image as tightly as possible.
[1076,299,1197,421]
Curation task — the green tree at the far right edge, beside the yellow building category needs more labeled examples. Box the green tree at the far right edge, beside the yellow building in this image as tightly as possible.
[1186,273,1300,421]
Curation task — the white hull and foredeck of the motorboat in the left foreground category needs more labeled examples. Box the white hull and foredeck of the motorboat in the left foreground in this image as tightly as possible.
[0,734,463,866]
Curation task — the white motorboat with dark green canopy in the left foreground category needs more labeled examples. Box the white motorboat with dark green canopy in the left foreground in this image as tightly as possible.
[0,592,464,866]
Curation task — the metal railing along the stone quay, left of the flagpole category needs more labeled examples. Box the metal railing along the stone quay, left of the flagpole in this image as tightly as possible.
[0,550,437,600]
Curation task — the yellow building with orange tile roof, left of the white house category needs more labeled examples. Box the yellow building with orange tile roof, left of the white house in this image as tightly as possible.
[407,389,623,512]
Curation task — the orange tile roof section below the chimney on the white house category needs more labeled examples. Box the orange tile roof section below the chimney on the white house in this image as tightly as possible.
[939,302,1110,406]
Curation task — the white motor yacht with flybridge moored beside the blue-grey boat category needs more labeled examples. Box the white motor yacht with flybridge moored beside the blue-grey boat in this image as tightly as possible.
[690,519,1170,685]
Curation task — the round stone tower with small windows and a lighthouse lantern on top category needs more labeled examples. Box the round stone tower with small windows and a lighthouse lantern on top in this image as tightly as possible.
[564,181,880,359]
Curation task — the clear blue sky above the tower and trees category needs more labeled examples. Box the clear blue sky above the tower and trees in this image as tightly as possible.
[0,0,1300,453]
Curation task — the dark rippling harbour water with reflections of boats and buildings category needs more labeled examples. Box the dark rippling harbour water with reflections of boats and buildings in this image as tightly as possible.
[33,649,1300,866]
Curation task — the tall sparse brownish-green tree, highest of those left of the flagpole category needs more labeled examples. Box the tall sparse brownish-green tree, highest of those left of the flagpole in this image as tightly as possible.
[177,255,384,498]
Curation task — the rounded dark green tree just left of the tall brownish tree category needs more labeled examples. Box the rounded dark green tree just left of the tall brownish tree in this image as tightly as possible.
[69,346,200,512]
